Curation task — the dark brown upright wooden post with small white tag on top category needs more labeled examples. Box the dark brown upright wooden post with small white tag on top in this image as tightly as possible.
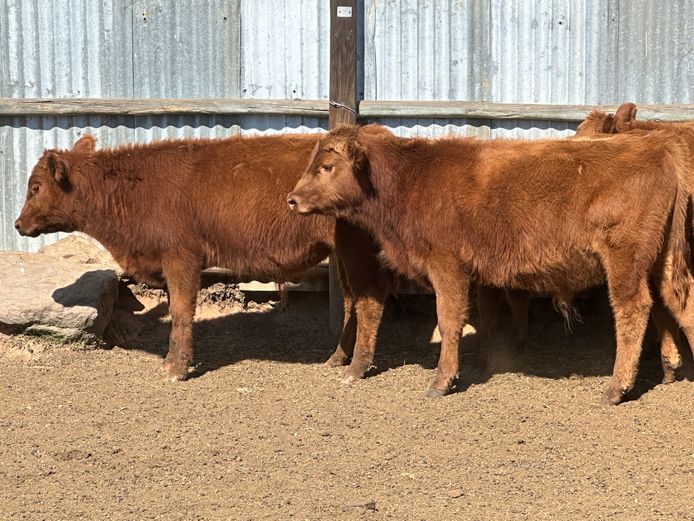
[328,0,357,333]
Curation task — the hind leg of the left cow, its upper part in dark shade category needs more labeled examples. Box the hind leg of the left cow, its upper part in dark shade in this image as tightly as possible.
[331,220,390,383]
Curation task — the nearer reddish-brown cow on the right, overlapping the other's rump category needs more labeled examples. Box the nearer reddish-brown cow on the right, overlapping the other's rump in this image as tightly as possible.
[288,126,690,403]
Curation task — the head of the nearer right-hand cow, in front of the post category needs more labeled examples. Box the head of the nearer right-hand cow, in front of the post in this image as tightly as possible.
[287,126,373,216]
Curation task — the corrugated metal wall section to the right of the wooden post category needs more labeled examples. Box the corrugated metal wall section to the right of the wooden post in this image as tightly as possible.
[364,0,694,138]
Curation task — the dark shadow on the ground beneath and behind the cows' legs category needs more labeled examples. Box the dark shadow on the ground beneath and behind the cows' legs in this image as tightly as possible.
[111,286,692,398]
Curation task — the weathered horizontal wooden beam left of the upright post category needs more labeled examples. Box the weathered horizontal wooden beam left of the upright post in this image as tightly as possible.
[0,98,328,117]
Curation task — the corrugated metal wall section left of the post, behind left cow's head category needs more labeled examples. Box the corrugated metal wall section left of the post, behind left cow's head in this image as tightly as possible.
[0,0,330,251]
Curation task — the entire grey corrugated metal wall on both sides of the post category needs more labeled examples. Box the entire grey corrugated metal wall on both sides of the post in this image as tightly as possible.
[0,0,694,250]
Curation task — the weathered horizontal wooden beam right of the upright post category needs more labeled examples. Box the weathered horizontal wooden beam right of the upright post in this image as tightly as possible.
[359,100,694,121]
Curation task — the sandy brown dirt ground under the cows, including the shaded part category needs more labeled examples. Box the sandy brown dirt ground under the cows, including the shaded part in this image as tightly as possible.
[0,286,694,521]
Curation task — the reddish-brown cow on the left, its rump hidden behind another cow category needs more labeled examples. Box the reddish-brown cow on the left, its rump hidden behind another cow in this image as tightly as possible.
[15,135,388,381]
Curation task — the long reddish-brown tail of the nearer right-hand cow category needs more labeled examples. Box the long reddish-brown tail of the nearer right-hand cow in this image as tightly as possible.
[668,143,692,309]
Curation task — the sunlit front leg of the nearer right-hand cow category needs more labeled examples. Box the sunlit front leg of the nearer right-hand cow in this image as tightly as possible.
[426,261,470,398]
